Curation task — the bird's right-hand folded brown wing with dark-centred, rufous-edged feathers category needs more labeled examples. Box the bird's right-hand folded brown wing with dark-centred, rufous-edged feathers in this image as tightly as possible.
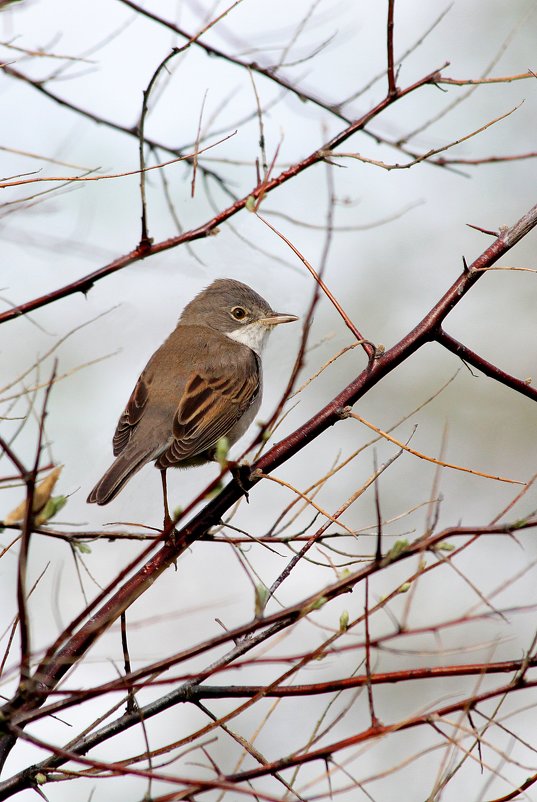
[155,353,259,469]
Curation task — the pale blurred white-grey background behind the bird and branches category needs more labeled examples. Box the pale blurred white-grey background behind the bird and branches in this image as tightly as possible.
[0,0,537,802]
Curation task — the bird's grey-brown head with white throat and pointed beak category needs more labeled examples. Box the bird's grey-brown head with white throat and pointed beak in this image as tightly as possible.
[180,278,298,353]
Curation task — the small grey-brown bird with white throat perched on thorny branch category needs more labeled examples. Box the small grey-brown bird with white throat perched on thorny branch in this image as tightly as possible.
[87,278,298,526]
